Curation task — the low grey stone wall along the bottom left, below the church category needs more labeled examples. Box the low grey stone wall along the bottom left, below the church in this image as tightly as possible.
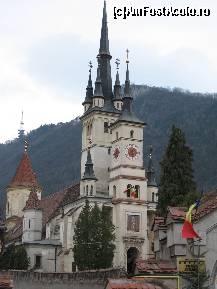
[0,269,125,289]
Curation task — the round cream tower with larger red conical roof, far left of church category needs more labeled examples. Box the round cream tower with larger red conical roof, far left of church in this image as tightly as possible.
[6,142,41,218]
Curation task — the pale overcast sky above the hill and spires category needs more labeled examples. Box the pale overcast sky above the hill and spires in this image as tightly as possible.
[0,0,217,142]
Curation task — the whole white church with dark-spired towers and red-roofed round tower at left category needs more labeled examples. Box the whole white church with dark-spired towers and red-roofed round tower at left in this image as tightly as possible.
[6,2,158,272]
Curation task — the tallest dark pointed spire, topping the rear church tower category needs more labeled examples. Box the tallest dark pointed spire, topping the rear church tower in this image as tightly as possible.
[98,1,112,100]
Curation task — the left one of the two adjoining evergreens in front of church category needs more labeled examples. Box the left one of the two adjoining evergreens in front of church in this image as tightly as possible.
[73,200,93,271]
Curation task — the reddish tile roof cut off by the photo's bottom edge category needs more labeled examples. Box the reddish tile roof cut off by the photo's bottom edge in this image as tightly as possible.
[106,278,162,289]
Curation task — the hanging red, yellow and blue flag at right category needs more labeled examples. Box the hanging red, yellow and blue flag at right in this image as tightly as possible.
[182,200,200,239]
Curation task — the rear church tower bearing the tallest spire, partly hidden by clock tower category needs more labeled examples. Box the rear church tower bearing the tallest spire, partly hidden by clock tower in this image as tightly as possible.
[81,2,120,197]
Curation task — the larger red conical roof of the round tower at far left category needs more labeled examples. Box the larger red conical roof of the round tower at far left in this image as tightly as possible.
[9,152,39,187]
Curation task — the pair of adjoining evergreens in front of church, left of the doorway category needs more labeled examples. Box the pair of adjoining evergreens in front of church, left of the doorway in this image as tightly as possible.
[73,201,115,271]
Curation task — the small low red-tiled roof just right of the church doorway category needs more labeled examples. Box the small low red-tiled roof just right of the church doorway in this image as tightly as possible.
[136,259,177,274]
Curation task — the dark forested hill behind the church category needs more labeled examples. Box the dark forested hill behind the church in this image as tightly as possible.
[0,85,217,208]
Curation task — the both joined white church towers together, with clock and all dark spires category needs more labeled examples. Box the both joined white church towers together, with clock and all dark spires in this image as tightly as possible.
[80,2,152,272]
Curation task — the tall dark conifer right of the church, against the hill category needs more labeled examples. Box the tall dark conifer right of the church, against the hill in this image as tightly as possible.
[157,126,197,216]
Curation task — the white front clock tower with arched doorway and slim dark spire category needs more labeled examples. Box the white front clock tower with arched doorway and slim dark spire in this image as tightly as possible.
[109,55,148,272]
